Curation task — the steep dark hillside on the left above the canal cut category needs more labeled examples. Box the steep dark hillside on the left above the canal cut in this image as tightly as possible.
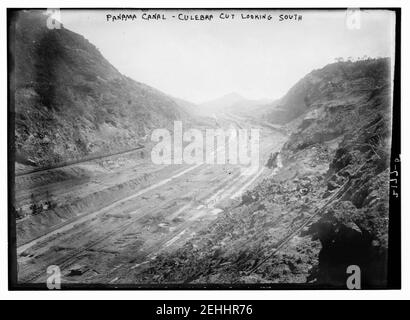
[11,10,189,165]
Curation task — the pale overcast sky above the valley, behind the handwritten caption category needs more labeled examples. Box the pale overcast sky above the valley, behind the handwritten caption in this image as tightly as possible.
[61,10,394,103]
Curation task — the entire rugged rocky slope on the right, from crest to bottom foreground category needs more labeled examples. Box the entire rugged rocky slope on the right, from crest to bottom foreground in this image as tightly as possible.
[131,59,391,288]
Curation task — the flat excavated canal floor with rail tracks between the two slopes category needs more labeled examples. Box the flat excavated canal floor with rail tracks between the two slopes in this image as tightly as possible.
[16,115,286,284]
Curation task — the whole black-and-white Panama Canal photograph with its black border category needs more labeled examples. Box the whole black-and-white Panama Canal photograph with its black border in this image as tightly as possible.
[4,7,401,290]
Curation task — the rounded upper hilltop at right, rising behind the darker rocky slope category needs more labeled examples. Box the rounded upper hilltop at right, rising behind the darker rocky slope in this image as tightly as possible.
[264,59,390,124]
